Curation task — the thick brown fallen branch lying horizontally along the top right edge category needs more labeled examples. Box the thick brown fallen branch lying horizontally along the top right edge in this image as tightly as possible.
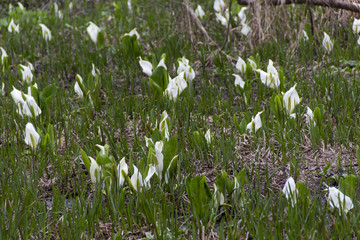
[238,0,360,12]
